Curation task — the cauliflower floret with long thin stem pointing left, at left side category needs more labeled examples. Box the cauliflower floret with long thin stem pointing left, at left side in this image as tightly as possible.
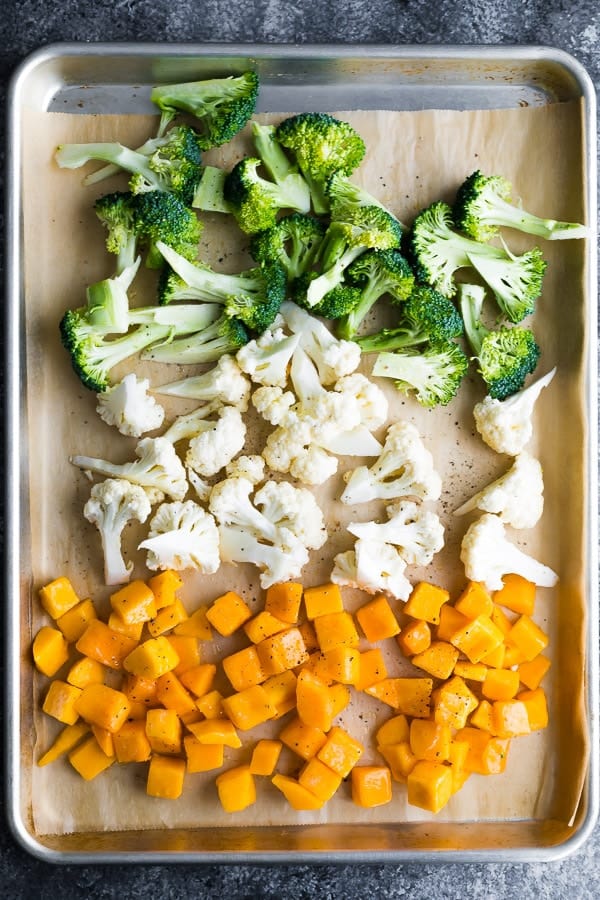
[69,437,188,500]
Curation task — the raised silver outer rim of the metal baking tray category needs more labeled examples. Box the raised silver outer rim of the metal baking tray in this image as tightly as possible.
[3,41,600,864]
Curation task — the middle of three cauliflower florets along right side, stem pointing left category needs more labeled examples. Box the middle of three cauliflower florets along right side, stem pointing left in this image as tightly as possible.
[454,451,544,528]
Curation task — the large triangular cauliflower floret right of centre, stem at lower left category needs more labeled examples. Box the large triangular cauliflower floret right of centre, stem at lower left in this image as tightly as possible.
[340,422,442,505]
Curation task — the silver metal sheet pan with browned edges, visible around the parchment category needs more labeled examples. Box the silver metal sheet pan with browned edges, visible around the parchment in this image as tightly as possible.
[6,45,597,861]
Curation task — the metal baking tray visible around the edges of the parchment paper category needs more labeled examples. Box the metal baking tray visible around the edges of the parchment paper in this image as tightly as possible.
[5,43,599,863]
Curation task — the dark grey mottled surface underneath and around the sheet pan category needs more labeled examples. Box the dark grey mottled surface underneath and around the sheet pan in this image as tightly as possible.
[0,0,600,900]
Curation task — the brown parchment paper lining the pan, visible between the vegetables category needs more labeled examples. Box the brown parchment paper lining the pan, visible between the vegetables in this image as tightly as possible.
[23,102,593,834]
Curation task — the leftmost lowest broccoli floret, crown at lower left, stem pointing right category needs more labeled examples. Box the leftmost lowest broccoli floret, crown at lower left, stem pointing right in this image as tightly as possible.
[60,310,172,393]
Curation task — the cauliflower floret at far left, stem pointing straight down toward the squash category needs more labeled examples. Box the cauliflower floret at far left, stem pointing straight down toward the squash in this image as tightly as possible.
[83,478,151,584]
